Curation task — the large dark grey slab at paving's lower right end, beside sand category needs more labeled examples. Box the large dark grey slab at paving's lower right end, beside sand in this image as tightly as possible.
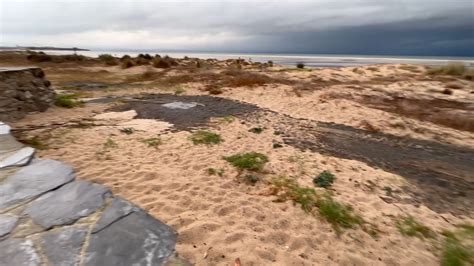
[85,211,176,266]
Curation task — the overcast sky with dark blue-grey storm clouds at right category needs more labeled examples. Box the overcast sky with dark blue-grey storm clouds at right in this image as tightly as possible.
[0,0,474,56]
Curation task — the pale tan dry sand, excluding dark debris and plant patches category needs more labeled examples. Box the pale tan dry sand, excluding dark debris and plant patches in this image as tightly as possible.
[8,59,474,265]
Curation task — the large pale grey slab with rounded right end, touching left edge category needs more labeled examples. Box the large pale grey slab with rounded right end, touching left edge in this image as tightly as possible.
[0,160,74,210]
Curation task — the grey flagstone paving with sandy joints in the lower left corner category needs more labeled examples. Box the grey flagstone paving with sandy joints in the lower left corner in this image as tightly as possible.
[0,123,189,266]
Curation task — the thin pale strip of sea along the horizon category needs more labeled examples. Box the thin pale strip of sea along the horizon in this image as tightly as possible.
[8,50,474,67]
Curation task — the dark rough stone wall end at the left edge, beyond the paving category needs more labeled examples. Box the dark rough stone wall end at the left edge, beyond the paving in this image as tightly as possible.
[0,67,55,122]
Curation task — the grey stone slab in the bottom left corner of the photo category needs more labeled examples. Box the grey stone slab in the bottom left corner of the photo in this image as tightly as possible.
[0,238,41,266]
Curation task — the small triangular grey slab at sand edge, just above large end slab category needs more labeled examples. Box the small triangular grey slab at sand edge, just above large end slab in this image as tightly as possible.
[92,197,139,233]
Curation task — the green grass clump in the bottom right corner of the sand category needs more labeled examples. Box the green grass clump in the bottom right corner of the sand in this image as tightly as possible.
[441,225,474,266]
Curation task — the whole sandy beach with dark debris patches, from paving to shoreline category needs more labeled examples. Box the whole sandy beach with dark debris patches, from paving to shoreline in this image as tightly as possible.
[0,53,474,265]
